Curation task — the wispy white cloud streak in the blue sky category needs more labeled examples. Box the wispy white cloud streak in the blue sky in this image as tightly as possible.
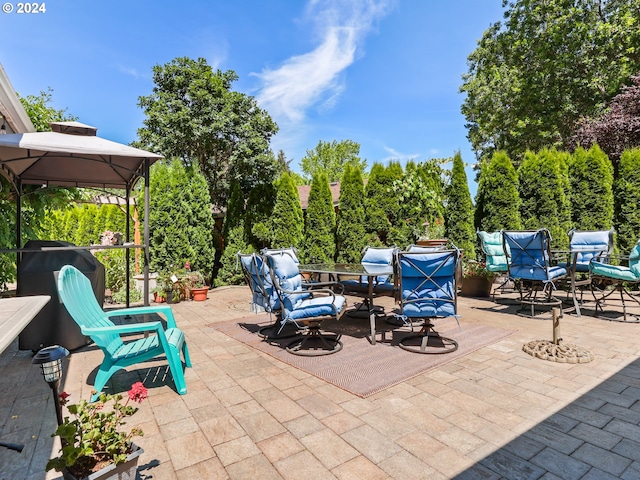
[256,0,389,122]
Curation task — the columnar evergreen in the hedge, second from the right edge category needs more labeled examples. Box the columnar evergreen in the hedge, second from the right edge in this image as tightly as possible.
[569,145,613,230]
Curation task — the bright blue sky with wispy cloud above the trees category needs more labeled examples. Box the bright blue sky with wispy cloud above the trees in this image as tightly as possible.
[0,0,503,194]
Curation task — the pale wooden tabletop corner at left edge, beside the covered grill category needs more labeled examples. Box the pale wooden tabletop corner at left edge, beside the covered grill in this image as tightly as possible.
[0,295,51,353]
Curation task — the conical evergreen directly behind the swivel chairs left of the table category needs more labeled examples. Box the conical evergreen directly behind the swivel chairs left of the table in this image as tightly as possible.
[268,173,304,248]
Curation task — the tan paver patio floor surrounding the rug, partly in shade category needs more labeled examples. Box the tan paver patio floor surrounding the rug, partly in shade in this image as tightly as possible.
[0,286,640,480]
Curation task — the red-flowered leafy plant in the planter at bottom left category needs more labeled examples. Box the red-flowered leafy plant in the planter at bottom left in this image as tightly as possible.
[46,382,147,478]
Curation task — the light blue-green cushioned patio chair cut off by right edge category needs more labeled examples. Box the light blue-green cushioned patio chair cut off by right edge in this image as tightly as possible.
[589,240,640,323]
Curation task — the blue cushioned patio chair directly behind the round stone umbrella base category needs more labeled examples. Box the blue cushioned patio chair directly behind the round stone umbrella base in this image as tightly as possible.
[503,228,567,318]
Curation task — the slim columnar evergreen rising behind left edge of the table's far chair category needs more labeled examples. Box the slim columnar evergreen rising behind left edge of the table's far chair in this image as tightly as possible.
[336,165,367,263]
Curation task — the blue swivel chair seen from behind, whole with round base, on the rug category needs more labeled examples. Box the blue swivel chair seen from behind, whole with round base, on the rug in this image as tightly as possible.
[396,248,460,354]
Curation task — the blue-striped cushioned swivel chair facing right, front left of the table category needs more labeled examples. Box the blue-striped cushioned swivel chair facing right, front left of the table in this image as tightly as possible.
[265,253,346,356]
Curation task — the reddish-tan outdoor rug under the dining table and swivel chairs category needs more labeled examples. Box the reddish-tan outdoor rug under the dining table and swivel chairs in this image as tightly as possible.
[208,314,514,397]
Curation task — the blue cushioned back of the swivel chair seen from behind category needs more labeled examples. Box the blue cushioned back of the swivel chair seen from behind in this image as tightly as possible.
[398,250,457,317]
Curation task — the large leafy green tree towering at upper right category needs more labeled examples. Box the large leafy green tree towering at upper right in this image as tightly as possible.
[460,0,640,164]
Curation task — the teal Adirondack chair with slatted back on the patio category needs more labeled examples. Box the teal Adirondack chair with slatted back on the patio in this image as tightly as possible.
[58,265,191,402]
